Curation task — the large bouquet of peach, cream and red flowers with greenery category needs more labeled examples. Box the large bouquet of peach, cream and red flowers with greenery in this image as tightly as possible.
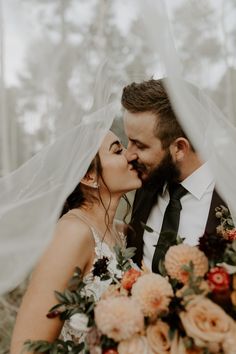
[26,206,236,354]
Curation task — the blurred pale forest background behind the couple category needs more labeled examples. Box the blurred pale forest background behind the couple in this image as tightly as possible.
[0,0,236,354]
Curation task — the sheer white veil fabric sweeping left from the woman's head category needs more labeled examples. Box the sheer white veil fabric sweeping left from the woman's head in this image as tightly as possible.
[0,104,117,292]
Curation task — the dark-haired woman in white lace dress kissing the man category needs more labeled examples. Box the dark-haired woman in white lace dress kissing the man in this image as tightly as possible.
[11,131,141,354]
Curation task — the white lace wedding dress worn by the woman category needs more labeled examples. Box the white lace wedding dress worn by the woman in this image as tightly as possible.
[60,222,125,343]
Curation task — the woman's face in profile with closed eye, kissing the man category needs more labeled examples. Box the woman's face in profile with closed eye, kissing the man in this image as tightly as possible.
[99,132,142,193]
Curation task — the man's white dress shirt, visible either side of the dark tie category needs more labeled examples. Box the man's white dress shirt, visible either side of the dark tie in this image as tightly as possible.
[143,163,215,269]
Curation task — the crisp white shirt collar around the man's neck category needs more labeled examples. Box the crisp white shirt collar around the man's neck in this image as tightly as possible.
[163,162,214,200]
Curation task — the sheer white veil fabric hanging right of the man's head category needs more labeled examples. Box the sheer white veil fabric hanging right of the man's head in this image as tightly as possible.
[137,0,236,220]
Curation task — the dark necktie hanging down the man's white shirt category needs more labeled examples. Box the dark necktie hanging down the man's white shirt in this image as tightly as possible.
[152,183,187,273]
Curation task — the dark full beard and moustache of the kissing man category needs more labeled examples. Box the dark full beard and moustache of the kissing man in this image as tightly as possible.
[132,151,180,190]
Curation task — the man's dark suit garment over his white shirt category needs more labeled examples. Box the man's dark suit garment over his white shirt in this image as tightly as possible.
[127,188,225,266]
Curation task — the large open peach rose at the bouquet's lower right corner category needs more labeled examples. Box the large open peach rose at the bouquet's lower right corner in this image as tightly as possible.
[180,296,233,353]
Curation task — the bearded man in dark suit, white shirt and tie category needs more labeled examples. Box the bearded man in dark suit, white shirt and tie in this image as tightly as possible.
[121,79,223,272]
